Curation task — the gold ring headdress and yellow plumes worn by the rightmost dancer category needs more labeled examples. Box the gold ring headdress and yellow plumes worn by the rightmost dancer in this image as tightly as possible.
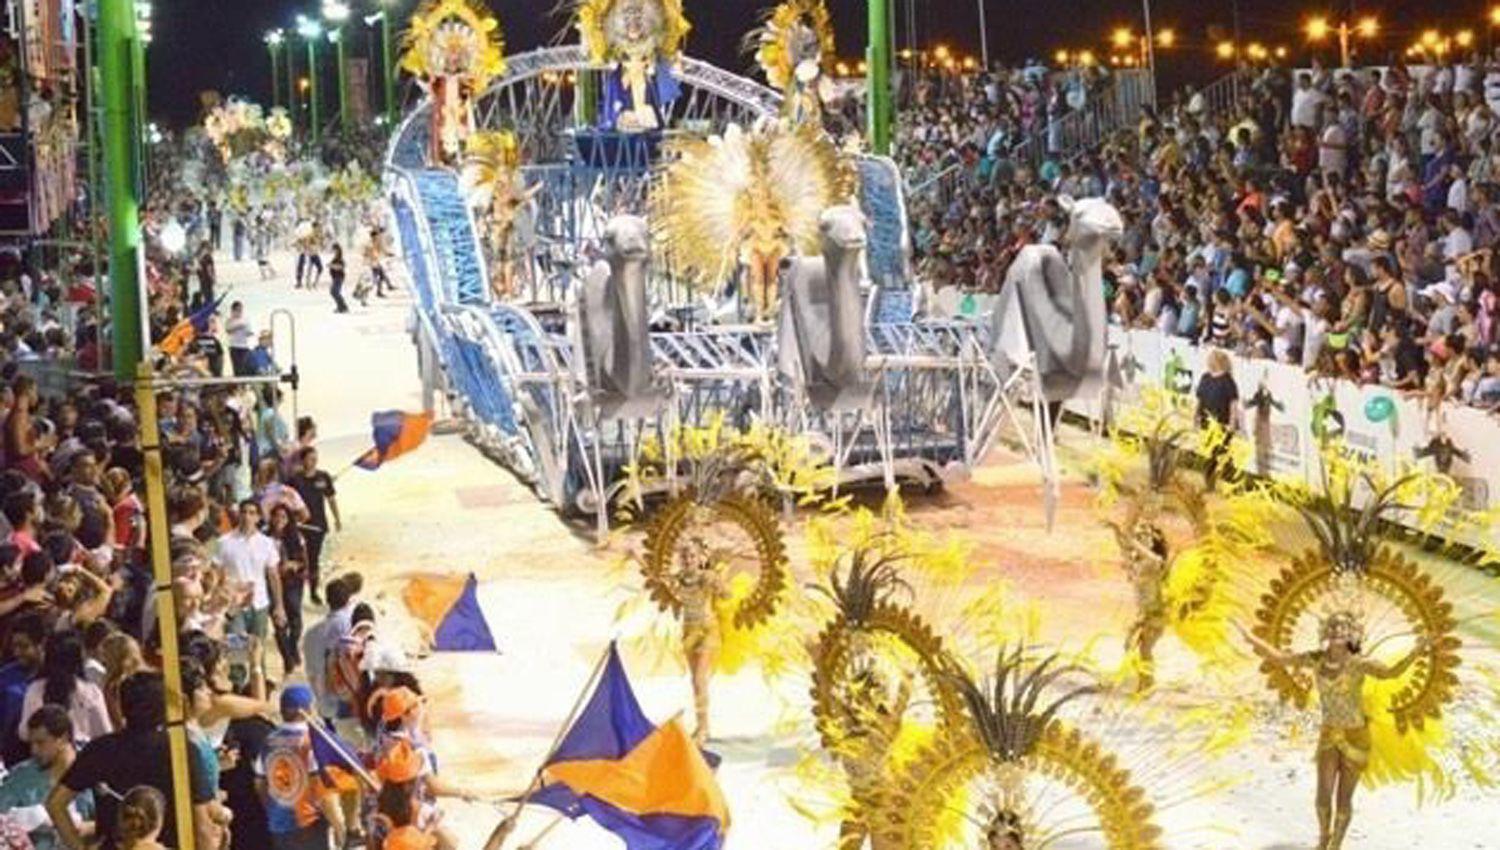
[1253,445,1463,789]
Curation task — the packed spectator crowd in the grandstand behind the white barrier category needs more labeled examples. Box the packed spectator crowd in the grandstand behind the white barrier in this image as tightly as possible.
[897,55,1500,409]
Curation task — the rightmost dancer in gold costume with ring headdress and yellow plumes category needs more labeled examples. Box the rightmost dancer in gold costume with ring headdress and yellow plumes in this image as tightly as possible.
[1235,447,1494,850]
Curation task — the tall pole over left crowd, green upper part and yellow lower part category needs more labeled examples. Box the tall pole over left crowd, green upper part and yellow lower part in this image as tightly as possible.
[98,0,197,850]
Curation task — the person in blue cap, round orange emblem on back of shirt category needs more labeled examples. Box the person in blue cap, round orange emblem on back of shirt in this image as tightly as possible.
[255,685,345,850]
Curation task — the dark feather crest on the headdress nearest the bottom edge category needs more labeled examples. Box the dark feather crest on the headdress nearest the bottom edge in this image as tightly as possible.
[950,645,1101,763]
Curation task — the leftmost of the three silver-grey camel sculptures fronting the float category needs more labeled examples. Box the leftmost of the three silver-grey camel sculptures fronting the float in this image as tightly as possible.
[578,216,662,420]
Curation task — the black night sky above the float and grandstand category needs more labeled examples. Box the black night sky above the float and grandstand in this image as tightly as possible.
[150,0,1490,124]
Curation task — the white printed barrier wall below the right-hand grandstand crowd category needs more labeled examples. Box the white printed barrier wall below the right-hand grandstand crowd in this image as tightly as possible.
[1092,327,1500,546]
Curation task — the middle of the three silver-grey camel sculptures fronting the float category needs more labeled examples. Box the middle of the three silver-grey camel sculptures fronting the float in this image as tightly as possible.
[779,207,873,411]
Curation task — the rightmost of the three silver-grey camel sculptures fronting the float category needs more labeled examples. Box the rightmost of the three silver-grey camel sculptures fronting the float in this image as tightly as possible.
[990,198,1125,526]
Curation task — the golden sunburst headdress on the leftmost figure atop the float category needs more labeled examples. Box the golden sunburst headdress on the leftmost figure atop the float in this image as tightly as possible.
[401,0,506,88]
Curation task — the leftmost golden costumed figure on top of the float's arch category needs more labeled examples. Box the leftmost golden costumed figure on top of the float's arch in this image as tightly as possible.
[401,0,506,166]
